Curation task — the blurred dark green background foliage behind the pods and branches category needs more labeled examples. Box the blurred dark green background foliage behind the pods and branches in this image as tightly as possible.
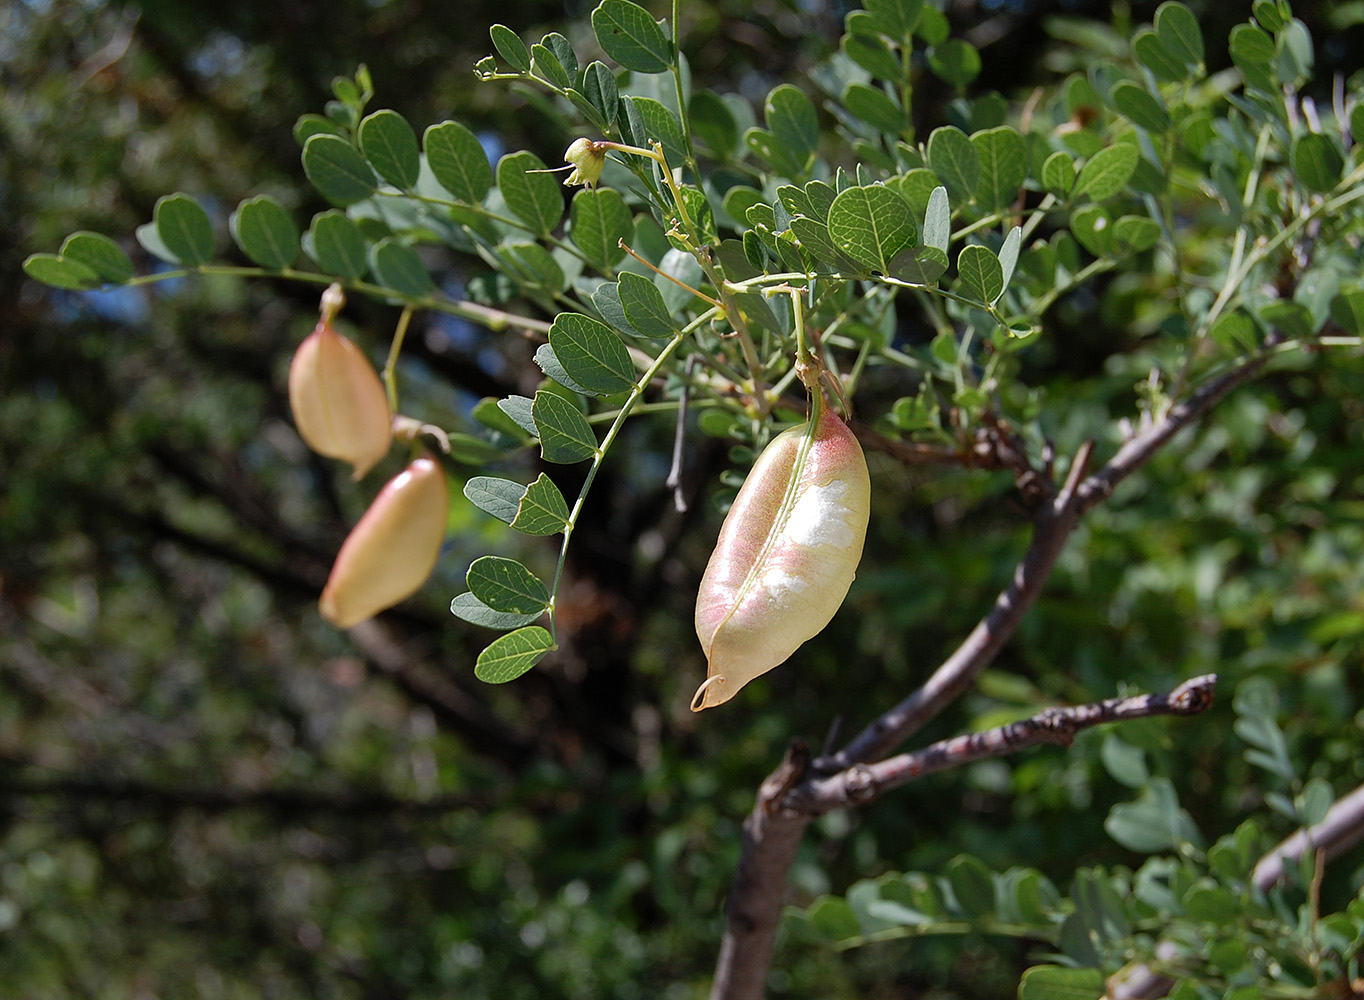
[8,0,1364,1000]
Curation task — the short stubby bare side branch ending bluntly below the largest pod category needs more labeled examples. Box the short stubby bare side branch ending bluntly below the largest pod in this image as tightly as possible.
[786,674,1217,817]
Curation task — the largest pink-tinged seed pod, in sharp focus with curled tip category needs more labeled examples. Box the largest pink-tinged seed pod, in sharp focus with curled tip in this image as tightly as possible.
[692,407,872,712]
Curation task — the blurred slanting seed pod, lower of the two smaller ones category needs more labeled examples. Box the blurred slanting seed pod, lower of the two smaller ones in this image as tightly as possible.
[318,457,450,629]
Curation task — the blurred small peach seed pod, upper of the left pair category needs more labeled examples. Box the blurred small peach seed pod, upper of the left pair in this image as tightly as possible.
[289,319,393,479]
